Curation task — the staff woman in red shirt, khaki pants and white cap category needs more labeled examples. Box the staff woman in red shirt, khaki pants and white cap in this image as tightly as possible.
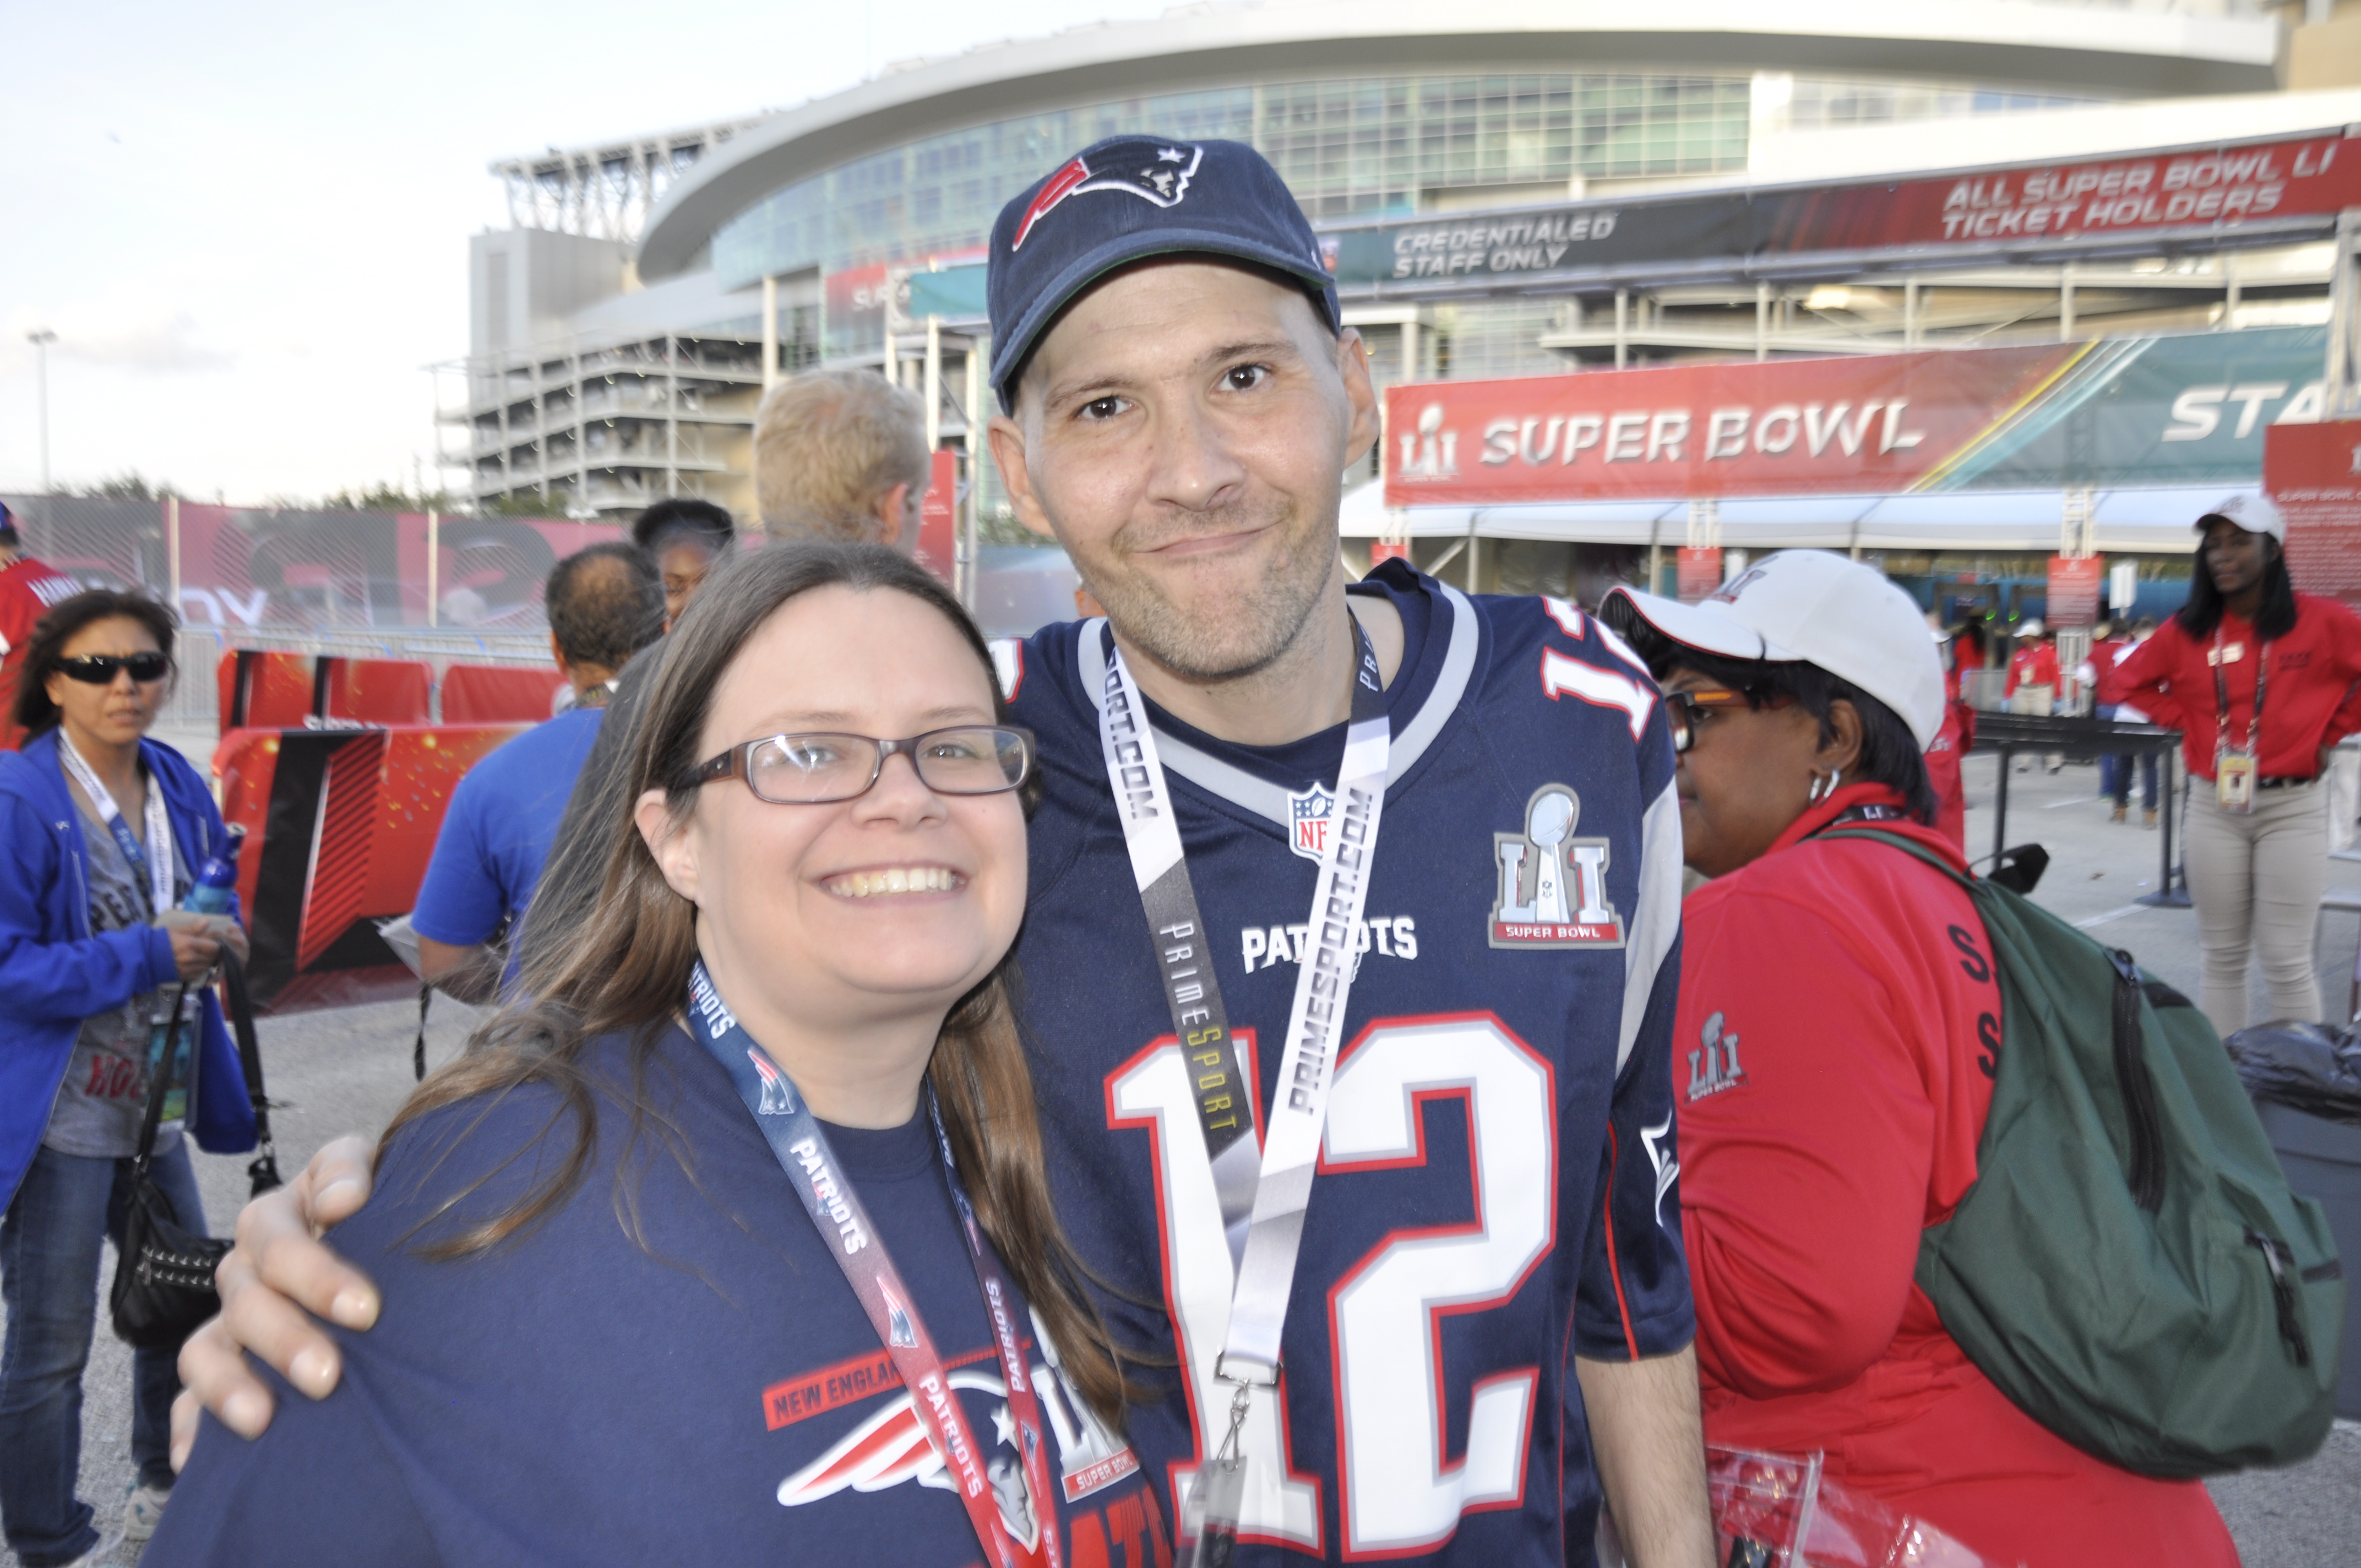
[2099,496,2361,1035]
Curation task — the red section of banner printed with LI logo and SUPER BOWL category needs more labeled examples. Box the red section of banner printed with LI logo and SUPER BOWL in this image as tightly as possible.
[1386,342,2077,505]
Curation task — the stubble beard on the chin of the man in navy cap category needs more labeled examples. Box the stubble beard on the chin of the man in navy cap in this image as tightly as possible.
[1089,505,1336,685]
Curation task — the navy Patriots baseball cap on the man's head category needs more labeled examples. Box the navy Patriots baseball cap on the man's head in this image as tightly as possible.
[984,137,1343,409]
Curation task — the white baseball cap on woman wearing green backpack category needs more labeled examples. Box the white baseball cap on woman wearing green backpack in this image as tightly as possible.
[1608,550,1943,749]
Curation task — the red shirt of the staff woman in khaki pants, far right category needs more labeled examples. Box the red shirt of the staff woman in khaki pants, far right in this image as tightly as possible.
[2099,593,2361,779]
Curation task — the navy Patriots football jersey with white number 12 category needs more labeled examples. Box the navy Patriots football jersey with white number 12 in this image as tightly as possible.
[1001,564,1693,1568]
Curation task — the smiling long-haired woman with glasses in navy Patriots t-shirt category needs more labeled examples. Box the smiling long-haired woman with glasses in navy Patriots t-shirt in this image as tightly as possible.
[149,543,1169,1568]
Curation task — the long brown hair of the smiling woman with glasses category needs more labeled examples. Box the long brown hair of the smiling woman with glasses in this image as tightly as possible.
[380,543,1136,1424]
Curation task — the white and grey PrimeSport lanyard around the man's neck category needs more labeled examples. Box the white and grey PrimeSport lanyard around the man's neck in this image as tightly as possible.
[1084,621,1393,1389]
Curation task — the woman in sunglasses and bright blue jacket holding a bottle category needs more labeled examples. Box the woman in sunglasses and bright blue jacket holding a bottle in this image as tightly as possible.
[0,588,246,1568]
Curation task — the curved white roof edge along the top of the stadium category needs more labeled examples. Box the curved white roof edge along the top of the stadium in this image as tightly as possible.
[640,0,2278,281]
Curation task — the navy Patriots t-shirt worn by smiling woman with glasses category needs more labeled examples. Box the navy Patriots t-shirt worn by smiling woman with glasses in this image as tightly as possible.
[146,1030,1171,1568]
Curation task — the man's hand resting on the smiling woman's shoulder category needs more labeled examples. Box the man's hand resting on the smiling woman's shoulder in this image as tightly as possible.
[172,1138,378,1469]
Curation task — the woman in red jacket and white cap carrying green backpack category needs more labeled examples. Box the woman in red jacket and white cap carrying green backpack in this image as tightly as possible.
[1601,550,2238,1568]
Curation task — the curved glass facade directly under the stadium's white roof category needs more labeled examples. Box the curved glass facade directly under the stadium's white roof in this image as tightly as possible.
[713,73,1749,288]
